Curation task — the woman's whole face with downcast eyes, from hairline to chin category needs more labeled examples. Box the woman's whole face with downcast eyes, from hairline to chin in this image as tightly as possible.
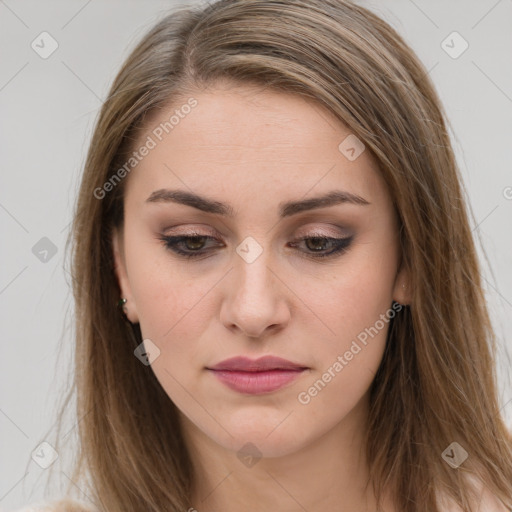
[113,86,406,457]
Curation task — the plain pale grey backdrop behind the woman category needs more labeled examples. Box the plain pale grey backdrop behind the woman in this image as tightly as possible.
[0,0,512,510]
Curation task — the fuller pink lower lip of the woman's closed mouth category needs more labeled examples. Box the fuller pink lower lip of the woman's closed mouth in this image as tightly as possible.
[207,369,304,395]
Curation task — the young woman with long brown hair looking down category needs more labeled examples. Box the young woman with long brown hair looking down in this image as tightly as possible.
[20,0,512,512]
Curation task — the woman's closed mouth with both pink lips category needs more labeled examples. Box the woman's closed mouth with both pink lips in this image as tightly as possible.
[206,356,309,395]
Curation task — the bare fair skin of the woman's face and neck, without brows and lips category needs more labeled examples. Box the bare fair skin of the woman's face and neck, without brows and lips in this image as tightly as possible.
[113,84,408,512]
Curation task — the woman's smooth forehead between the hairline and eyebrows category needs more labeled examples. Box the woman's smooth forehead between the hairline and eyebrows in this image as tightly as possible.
[123,85,386,209]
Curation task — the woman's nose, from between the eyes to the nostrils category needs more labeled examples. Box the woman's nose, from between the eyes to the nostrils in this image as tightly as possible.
[220,251,291,338]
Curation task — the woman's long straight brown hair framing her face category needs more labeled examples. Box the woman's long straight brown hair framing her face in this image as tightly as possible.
[35,0,512,512]
